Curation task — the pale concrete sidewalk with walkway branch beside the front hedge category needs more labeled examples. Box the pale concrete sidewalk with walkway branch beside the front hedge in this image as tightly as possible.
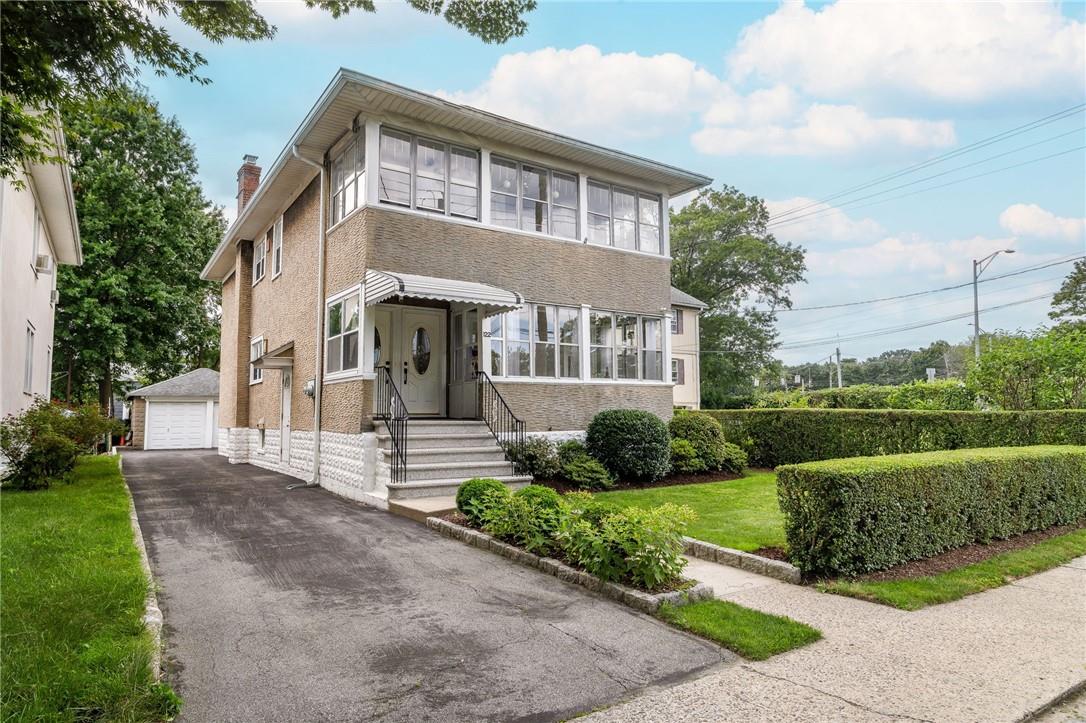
[589,557,1086,723]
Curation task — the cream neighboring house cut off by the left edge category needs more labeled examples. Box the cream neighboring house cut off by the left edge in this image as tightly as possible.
[0,123,83,416]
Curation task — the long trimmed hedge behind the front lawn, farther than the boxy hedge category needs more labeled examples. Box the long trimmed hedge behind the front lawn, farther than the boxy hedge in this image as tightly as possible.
[706,409,1086,467]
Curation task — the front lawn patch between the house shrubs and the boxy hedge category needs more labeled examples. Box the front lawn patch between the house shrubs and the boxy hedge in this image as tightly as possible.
[596,472,786,553]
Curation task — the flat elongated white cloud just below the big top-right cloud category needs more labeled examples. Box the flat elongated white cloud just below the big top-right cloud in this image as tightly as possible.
[693,103,955,156]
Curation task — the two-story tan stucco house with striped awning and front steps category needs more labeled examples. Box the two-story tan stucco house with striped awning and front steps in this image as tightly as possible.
[203,71,711,506]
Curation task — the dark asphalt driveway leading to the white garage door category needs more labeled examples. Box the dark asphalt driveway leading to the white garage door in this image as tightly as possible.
[124,451,732,721]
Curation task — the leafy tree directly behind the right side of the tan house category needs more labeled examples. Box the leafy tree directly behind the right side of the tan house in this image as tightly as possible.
[671,186,806,406]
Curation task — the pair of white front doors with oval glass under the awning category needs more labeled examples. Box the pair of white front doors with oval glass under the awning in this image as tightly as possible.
[374,304,445,416]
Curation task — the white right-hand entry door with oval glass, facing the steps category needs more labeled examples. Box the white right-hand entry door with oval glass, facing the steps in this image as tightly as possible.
[393,307,445,415]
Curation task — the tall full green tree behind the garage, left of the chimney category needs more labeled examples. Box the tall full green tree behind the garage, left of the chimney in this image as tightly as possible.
[53,90,225,408]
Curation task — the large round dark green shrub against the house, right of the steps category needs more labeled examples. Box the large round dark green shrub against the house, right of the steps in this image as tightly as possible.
[585,409,671,482]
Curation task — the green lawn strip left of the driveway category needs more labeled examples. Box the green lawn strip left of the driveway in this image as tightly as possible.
[0,457,179,721]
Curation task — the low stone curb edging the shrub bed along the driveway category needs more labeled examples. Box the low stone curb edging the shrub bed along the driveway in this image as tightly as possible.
[426,517,714,614]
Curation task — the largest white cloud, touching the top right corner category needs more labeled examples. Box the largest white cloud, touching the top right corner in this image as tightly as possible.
[729,1,1086,102]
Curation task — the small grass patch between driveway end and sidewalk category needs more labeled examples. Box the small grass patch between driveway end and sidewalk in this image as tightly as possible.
[659,600,822,660]
